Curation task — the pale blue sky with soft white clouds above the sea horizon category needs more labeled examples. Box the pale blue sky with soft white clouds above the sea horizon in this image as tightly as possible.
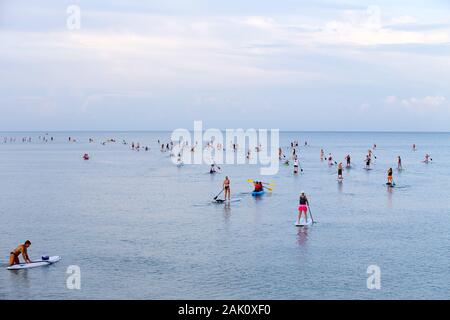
[0,0,450,131]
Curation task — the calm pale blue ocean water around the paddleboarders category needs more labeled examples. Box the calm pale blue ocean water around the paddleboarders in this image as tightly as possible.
[0,132,450,299]
